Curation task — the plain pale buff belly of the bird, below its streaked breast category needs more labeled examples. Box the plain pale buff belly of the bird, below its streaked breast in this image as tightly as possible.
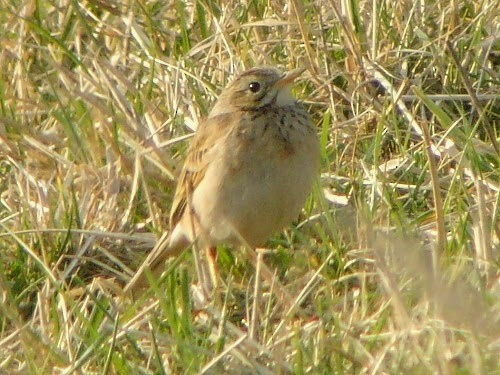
[189,128,319,246]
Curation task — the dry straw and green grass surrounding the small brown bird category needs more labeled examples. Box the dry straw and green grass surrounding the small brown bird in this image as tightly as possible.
[0,0,500,374]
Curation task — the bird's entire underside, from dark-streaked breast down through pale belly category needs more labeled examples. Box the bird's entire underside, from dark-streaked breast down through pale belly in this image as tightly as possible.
[189,105,319,245]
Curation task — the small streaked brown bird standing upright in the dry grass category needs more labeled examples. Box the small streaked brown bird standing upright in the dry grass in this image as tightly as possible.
[125,68,319,291]
